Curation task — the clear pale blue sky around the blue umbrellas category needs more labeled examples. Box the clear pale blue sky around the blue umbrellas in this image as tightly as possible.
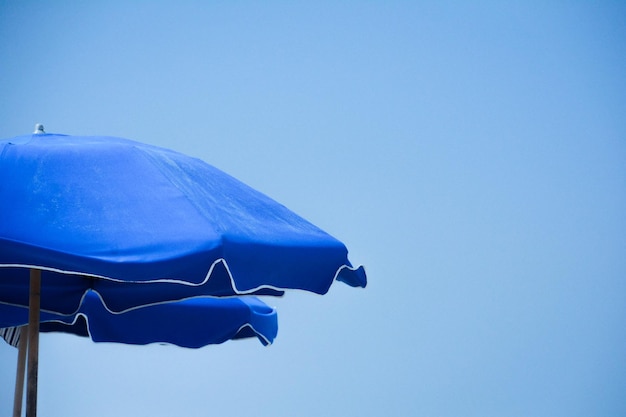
[0,0,626,417]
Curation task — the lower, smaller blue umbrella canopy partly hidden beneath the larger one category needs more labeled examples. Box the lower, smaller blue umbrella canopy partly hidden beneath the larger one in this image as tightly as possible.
[0,291,278,348]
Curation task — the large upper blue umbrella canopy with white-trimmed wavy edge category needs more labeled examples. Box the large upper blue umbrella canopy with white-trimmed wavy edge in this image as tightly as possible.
[0,134,366,314]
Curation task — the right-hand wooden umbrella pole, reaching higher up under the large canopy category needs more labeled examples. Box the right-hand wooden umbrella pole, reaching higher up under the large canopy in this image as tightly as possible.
[26,269,41,417]
